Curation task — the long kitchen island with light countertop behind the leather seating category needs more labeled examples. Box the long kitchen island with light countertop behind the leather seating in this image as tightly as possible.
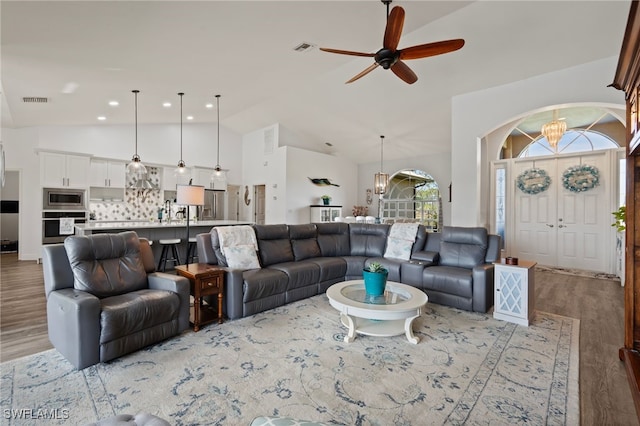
[75,220,253,264]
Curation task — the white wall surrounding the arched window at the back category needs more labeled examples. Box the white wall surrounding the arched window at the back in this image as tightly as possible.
[357,152,456,225]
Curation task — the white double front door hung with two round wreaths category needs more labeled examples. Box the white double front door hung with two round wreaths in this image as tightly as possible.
[509,151,614,272]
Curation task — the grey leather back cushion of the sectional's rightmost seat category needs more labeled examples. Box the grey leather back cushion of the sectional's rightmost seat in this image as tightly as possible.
[439,226,487,269]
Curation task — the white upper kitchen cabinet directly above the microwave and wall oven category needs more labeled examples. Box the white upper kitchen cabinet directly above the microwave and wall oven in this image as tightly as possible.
[39,151,89,188]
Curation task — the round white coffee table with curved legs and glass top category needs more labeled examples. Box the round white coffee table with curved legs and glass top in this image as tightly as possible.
[327,280,429,344]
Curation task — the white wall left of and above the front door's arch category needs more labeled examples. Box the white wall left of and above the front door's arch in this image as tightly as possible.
[451,57,624,230]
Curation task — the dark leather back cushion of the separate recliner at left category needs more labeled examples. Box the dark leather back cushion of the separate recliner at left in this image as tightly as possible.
[64,231,147,298]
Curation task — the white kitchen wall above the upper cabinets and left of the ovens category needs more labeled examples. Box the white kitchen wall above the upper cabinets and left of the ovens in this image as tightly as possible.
[2,120,242,260]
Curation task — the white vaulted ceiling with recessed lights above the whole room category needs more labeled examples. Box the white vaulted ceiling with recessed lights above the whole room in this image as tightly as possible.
[0,0,629,163]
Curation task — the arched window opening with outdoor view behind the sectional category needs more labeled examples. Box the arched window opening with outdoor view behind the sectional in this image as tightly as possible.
[380,169,442,232]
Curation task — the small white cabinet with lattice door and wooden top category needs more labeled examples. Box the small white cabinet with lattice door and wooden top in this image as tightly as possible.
[493,261,536,327]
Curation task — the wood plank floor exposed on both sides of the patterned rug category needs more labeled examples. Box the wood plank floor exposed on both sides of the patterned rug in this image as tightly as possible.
[0,253,639,426]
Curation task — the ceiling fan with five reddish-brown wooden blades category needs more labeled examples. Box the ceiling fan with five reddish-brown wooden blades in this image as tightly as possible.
[320,0,464,84]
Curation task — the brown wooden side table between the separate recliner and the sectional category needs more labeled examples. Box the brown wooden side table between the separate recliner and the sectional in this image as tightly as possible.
[176,263,224,331]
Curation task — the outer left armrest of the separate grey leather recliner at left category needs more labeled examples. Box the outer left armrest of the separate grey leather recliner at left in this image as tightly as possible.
[47,288,100,370]
